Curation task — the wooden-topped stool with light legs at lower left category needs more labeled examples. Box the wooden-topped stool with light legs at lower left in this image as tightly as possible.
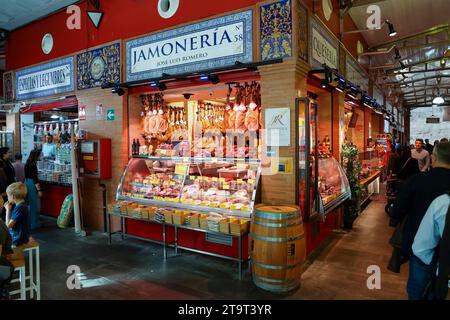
[20,237,41,300]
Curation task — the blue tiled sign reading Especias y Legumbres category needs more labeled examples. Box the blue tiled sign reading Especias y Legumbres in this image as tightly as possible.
[16,57,75,100]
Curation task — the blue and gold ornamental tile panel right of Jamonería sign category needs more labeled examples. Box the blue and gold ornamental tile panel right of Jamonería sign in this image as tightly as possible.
[260,0,292,61]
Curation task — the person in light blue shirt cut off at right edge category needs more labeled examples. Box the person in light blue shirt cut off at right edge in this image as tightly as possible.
[412,192,450,300]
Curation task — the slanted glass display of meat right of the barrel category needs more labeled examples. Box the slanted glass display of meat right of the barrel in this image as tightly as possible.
[318,156,351,214]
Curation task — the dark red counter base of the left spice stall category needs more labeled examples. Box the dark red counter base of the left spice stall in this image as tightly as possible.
[39,182,72,218]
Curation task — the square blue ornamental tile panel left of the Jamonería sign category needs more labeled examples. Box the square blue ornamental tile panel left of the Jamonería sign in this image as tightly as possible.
[77,43,121,90]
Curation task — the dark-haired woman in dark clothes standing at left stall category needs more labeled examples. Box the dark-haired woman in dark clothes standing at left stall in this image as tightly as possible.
[25,149,42,230]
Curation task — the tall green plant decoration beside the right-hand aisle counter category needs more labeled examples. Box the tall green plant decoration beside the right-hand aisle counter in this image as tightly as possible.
[342,144,362,229]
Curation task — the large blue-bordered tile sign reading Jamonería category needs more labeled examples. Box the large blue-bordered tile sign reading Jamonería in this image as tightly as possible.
[126,10,253,81]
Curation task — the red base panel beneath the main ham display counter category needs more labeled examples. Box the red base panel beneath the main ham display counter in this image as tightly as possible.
[125,219,248,259]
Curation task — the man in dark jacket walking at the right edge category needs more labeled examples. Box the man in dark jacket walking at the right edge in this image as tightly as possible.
[391,142,450,299]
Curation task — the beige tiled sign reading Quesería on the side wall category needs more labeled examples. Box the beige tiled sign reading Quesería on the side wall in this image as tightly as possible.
[310,19,339,69]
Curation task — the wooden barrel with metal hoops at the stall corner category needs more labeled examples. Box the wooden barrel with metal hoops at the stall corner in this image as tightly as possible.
[250,204,306,293]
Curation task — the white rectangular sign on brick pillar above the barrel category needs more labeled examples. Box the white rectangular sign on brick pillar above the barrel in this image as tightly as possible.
[265,108,291,147]
